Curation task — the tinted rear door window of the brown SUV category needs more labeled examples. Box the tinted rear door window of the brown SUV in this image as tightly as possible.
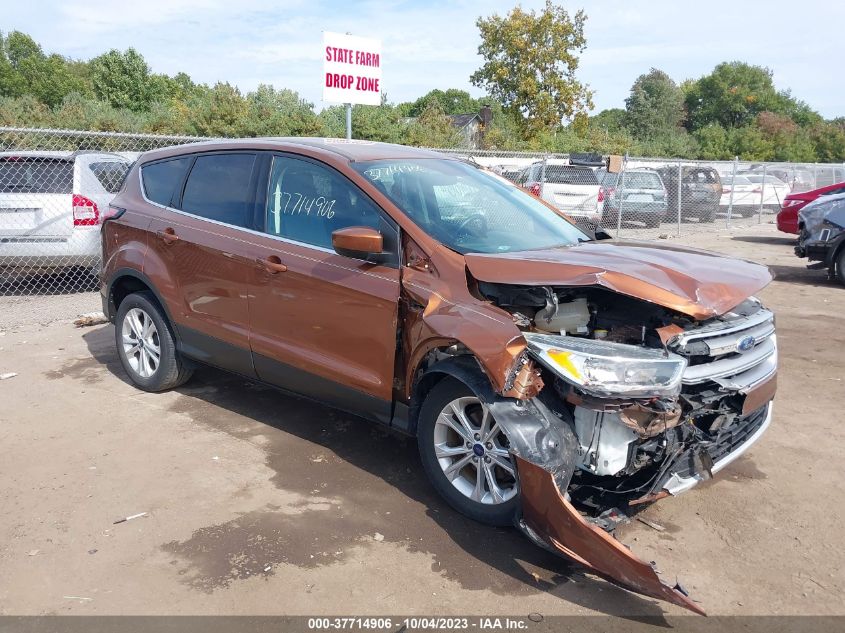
[182,154,255,226]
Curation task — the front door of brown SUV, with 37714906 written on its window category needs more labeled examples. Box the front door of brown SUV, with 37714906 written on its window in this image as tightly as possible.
[250,154,399,422]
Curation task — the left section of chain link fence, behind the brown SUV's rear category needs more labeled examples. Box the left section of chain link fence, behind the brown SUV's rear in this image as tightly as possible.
[0,127,205,296]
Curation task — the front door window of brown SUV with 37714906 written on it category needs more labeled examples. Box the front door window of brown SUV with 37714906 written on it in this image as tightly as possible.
[266,156,380,248]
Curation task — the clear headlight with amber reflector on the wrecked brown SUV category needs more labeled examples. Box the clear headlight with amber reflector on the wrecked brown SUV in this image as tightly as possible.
[524,334,687,398]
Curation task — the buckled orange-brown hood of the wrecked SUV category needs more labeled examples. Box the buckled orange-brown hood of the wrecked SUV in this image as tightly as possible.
[464,240,772,319]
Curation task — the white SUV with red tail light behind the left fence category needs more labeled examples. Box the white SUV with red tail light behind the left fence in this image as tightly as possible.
[0,151,132,271]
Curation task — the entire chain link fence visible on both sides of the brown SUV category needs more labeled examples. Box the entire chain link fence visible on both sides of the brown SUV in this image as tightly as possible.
[0,127,845,310]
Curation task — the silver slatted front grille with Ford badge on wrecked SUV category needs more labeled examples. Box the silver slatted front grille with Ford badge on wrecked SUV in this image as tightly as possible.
[670,300,777,391]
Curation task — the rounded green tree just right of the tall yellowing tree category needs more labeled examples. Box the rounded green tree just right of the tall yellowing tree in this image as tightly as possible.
[625,68,684,139]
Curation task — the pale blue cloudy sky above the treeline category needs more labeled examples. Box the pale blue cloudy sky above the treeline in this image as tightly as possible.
[0,0,845,118]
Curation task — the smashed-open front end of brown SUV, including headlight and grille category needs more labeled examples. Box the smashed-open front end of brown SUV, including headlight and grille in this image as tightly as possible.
[478,282,777,512]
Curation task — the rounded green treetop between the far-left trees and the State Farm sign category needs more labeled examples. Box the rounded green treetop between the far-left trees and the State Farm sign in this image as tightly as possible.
[89,48,155,112]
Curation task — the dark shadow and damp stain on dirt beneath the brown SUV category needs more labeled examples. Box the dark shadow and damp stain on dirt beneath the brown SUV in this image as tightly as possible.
[79,326,663,619]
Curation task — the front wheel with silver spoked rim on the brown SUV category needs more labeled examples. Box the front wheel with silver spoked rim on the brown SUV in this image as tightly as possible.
[417,378,520,525]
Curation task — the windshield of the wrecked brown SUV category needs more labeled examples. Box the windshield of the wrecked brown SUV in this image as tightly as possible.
[353,158,589,254]
